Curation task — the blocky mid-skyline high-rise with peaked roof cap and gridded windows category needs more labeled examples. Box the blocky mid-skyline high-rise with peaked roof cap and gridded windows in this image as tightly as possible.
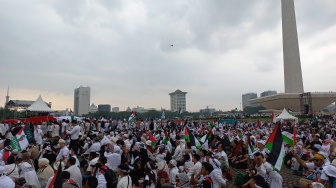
[169,89,187,112]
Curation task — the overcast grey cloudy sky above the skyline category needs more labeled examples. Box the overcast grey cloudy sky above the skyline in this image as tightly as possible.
[0,0,336,111]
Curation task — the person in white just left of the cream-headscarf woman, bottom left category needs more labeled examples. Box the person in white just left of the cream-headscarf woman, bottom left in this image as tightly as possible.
[19,151,41,188]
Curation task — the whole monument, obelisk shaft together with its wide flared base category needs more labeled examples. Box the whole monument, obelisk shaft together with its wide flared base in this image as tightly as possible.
[250,0,336,112]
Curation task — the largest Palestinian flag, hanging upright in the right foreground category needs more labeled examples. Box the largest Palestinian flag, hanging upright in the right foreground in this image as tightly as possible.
[266,124,285,171]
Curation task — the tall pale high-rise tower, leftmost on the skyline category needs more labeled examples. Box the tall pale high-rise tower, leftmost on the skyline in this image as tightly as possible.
[74,86,90,116]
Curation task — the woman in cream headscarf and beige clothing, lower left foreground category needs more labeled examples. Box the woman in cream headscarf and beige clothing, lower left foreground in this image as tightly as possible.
[36,158,54,187]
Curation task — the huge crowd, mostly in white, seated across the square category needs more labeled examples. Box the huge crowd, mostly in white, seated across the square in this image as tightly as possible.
[0,115,336,188]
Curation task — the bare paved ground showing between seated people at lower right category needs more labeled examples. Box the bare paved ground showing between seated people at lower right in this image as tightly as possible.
[226,167,301,188]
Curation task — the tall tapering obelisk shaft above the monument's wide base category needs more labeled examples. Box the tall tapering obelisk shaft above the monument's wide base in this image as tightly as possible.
[281,0,303,93]
